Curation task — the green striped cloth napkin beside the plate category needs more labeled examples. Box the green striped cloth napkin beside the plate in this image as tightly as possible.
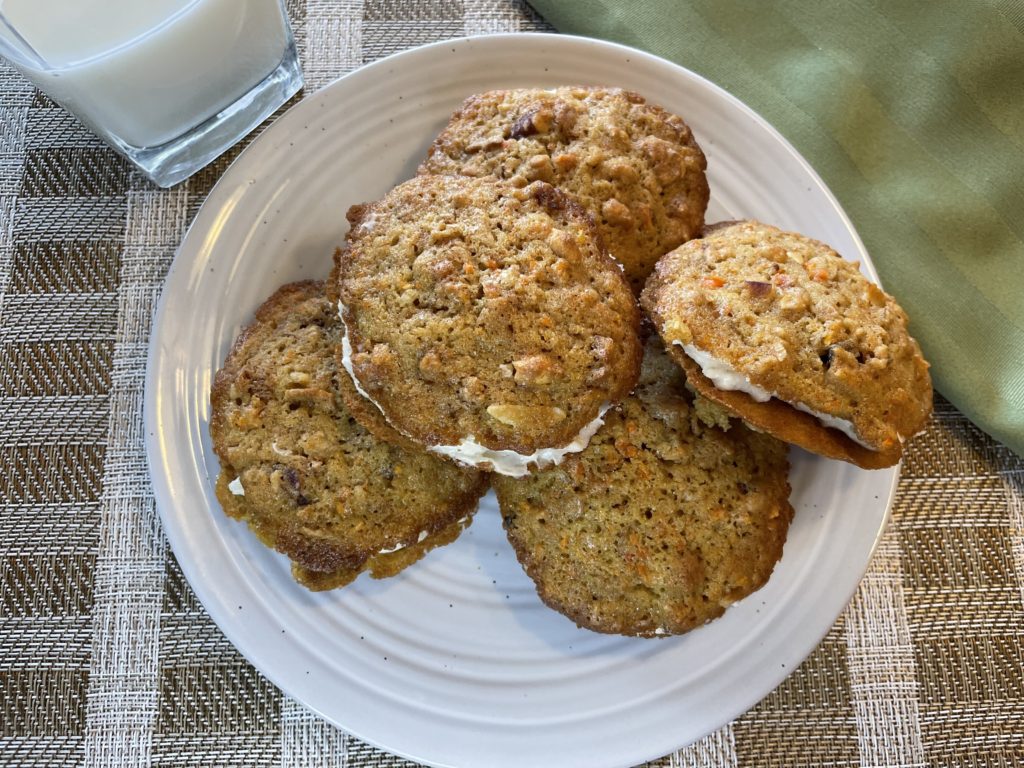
[530,0,1024,455]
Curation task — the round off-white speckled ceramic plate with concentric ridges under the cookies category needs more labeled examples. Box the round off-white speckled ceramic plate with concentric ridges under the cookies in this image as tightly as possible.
[145,35,896,768]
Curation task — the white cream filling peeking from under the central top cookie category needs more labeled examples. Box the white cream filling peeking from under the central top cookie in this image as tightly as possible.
[338,300,611,477]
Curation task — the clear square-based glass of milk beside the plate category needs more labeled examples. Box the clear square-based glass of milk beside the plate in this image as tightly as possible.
[0,0,302,186]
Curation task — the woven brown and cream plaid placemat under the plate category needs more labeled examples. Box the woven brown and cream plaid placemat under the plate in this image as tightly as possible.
[0,0,1024,768]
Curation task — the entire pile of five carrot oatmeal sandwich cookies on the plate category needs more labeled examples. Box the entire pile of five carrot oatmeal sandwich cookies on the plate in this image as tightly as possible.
[211,87,931,637]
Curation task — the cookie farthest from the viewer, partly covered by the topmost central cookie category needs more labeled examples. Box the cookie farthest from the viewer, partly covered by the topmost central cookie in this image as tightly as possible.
[420,87,709,293]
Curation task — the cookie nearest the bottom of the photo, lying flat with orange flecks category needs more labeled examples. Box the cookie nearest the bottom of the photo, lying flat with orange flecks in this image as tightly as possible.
[494,336,793,637]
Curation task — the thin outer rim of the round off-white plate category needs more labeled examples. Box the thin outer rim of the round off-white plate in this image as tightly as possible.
[142,32,901,766]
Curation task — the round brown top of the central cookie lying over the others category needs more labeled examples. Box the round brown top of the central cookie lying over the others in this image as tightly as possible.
[338,176,640,471]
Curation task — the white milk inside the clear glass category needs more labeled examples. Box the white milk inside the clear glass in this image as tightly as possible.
[0,0,288,147]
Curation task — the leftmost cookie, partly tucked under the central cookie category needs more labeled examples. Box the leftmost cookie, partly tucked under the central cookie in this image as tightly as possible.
[210,282,486,589]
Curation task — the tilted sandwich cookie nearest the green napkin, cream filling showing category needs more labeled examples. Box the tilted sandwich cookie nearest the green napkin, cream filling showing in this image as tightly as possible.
[641,221,932,468]
